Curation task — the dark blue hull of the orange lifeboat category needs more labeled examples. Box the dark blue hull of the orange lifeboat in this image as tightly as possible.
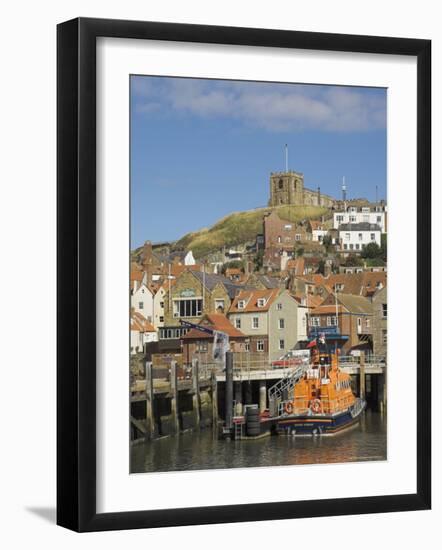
[276,400,365,436]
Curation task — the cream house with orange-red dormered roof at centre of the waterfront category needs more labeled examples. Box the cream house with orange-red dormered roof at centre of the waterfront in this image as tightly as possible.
[228,288,305,361]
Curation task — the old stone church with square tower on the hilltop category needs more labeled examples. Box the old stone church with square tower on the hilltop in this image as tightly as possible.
[269,170,336,208]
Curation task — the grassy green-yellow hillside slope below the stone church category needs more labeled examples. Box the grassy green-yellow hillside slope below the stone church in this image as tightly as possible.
[175,206,330,258]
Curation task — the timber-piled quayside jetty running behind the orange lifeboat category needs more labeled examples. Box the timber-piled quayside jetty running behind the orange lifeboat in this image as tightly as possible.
[130,351,387,444]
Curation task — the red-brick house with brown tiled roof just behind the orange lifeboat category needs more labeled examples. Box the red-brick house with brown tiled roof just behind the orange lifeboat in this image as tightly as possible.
[309,292,373,353]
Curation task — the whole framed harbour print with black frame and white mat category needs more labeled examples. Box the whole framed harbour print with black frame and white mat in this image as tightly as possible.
[57,19,431,531]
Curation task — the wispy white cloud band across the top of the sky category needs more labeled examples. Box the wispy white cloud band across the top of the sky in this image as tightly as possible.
[133,77,386,132]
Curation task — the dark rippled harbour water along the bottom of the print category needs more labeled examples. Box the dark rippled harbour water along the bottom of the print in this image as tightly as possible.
[131,410,387,473]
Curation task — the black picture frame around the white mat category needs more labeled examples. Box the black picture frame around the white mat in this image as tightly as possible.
[57,18,431,531]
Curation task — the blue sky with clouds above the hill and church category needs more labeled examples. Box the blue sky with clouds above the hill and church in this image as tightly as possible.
[131,76,386,247]
